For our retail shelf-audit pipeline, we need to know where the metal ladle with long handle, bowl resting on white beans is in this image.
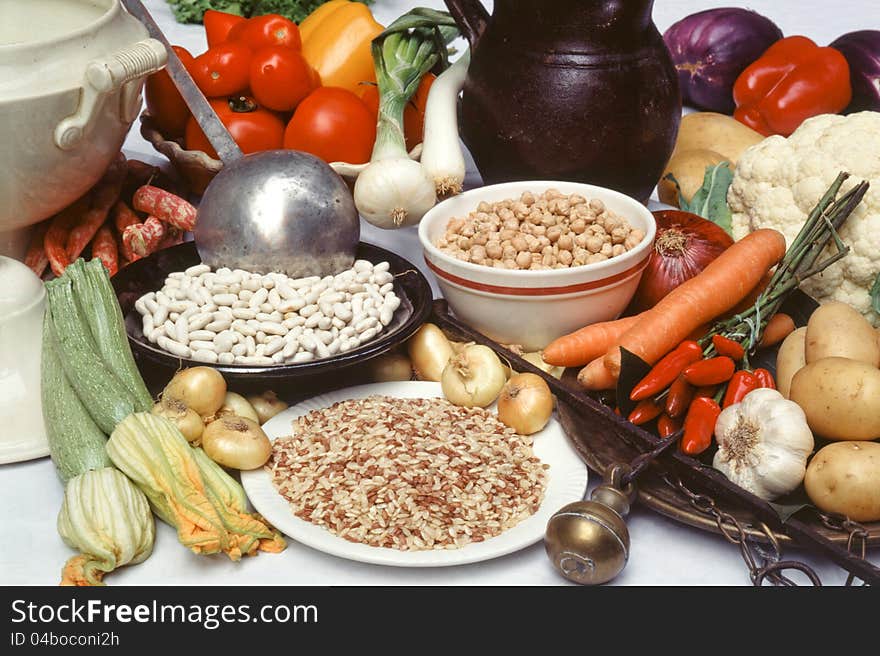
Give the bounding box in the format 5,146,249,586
122,0,360,277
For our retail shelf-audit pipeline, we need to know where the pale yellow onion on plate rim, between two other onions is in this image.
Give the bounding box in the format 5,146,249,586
440,344,507,408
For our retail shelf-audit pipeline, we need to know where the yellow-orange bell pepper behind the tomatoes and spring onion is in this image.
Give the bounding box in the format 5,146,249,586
299,0,385,93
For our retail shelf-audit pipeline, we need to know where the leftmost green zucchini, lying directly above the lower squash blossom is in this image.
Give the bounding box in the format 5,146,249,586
40,314,112,483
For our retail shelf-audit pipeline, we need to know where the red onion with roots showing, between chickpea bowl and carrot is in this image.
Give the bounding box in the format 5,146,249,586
630,210,733,312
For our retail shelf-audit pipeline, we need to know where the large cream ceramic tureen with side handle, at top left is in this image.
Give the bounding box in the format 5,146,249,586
0,0,167,258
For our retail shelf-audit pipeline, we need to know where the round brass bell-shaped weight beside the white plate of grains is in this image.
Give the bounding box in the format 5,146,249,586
544,465,635,585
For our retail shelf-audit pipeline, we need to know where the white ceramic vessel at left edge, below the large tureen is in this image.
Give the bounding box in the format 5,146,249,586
0,255,49,463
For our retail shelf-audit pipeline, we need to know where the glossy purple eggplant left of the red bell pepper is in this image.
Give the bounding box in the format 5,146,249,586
663,7,782,114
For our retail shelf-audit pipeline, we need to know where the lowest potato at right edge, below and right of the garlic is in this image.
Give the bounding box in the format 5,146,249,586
804,442,880,522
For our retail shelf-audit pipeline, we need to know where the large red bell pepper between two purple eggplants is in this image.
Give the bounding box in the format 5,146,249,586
733,36,852,137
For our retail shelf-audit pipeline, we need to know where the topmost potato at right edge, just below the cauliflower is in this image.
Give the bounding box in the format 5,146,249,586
804,301,880,367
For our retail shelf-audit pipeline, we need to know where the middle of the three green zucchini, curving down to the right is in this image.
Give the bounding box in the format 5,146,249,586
46,276,142,435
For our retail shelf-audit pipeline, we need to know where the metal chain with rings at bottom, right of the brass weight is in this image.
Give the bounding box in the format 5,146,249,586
661,472,822,586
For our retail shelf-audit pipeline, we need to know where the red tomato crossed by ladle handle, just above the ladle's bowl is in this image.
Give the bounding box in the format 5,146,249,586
186,96,284,159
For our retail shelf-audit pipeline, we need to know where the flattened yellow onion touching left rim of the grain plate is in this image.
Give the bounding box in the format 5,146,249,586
202,415,272,469
